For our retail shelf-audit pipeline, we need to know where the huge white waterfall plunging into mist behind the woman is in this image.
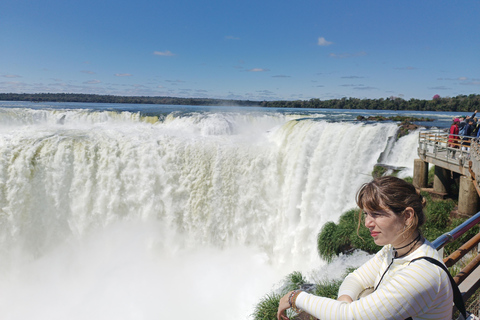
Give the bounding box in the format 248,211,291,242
0,104,416,319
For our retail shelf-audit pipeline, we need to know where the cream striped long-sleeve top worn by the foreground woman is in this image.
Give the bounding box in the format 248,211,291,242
295,240,453,320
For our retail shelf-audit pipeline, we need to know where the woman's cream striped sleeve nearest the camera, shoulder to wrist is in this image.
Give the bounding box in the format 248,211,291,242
295,262,453,320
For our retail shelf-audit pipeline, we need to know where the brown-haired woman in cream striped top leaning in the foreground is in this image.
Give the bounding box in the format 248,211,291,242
277,177,453,320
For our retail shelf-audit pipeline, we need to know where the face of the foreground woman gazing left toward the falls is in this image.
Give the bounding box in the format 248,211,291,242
364,209,405,247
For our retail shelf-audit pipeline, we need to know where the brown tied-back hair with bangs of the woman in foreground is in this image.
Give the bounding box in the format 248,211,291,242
356,176,425,235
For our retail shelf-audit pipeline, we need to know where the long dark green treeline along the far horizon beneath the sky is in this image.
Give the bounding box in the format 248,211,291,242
0,93,480,113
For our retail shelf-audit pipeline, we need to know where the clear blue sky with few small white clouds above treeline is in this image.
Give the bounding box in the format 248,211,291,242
0,0,480,100
